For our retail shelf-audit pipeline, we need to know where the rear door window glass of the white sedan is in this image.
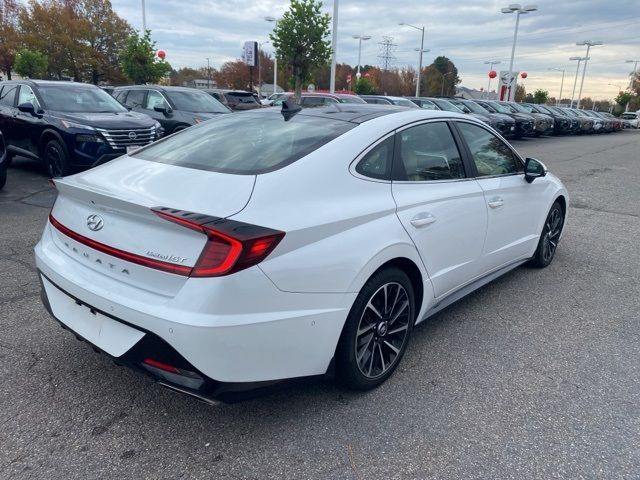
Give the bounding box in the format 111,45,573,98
395,122,465,182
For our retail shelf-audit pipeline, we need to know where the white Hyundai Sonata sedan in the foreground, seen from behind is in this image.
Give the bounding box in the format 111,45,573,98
35,103,569,401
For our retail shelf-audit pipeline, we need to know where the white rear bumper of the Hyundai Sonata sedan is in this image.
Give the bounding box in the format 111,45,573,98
35,224,356,398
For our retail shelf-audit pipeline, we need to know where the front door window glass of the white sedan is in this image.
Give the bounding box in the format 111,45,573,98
457,122,518,177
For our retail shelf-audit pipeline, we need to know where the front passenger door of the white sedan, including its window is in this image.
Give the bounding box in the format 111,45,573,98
455,121,549,273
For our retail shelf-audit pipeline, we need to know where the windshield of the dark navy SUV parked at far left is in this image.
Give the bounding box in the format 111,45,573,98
38,84,127,113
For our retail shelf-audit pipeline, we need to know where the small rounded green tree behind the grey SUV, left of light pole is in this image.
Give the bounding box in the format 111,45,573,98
120,30,171,84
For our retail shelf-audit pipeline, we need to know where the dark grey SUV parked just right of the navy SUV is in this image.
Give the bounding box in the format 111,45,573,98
113,85,231,135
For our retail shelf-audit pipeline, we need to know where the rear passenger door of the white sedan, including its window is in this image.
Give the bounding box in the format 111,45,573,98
392,121,487,298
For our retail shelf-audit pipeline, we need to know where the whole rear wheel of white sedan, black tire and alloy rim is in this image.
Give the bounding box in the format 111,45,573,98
336,267,416,390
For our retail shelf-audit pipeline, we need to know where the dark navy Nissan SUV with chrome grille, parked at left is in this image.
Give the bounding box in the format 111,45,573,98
0,80,162,177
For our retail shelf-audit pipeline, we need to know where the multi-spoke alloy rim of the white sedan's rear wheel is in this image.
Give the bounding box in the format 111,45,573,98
354,282,411,379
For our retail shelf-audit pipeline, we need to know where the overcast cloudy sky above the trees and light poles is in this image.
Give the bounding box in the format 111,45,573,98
112,0,640,98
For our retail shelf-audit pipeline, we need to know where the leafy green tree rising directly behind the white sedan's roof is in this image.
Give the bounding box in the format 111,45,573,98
269,0,331,101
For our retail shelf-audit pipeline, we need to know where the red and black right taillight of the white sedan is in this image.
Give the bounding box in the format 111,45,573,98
152,207,284,277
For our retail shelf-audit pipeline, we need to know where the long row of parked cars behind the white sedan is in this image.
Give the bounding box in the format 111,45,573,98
0,80,637,188
